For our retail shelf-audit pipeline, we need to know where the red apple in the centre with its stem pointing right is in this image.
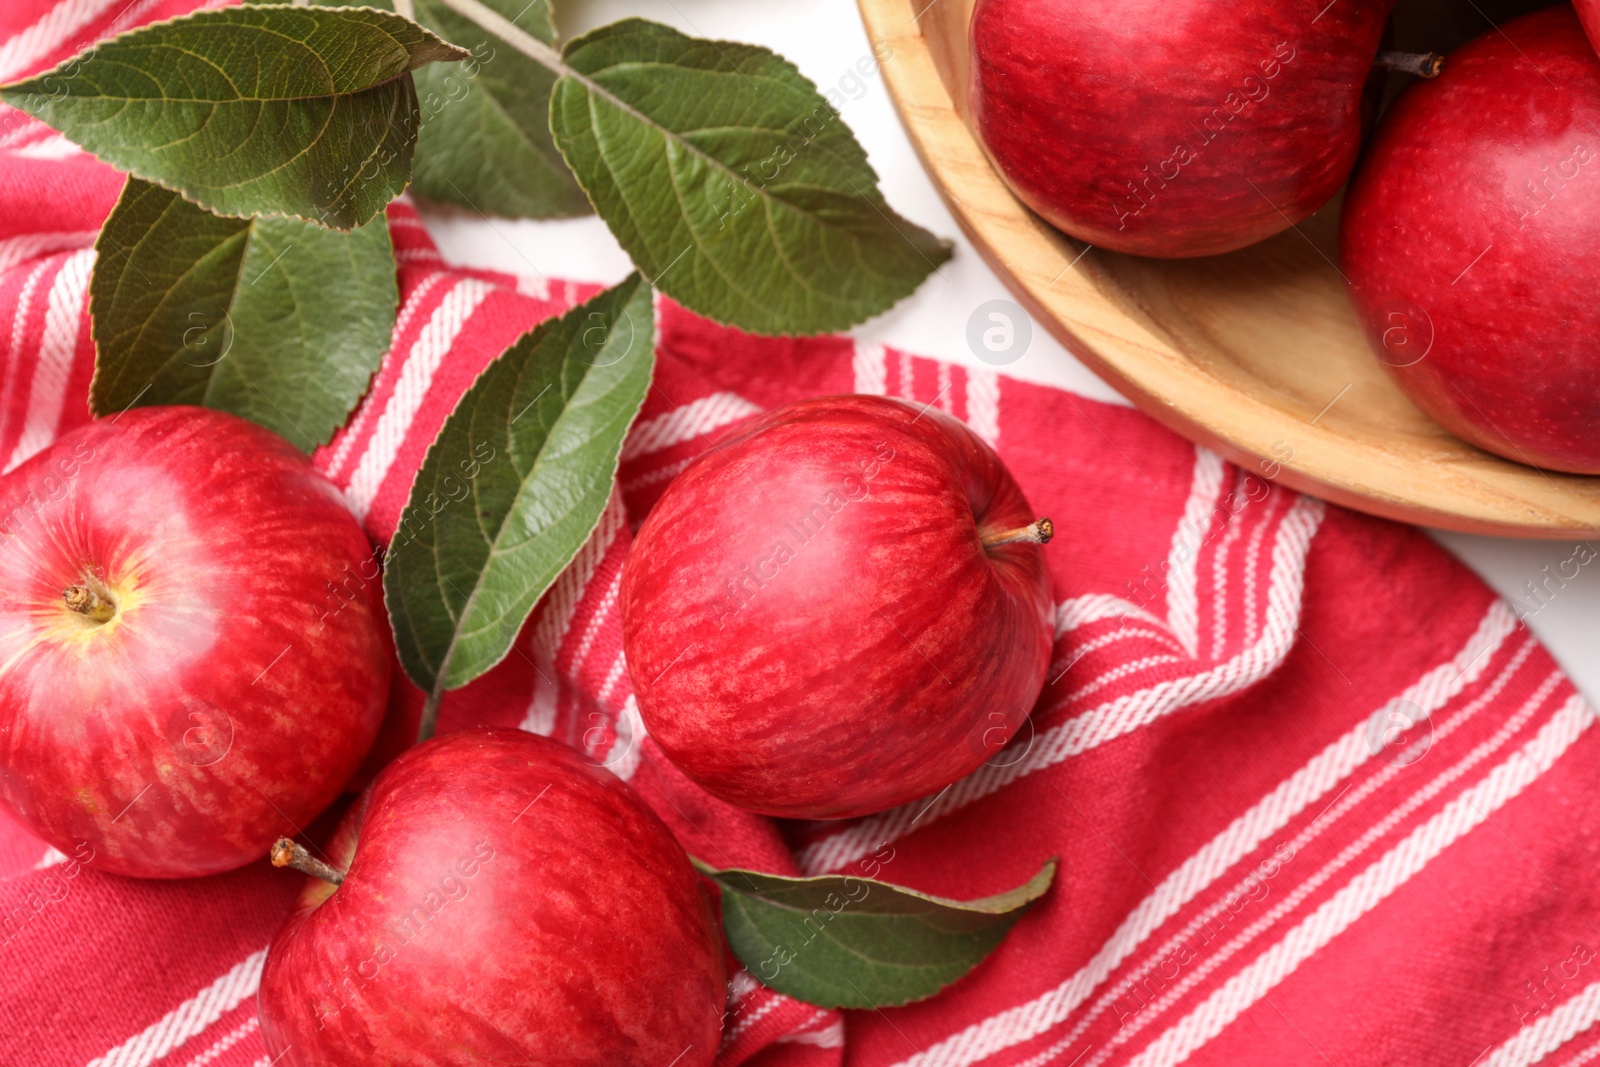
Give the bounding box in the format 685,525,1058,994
621,397,1053,819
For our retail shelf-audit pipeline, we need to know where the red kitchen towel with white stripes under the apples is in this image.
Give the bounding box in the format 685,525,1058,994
0,0,1600,1067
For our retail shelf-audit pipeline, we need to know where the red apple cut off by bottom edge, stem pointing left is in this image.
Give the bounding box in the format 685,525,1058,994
259,729,726,1067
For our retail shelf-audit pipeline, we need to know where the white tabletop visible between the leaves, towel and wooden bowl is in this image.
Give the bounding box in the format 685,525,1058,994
427,0,1600,704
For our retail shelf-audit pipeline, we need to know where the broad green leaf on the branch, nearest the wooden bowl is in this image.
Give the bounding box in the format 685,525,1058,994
550,16,950,334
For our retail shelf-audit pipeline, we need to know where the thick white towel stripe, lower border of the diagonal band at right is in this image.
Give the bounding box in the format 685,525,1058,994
1130,696,1595,1067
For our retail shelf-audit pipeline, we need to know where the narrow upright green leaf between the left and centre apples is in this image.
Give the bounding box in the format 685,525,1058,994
384,274,656,736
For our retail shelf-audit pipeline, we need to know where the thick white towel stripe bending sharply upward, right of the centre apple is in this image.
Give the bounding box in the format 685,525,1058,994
797,496,1326,873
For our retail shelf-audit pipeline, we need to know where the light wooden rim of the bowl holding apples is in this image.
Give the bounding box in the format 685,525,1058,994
858,0,1600,539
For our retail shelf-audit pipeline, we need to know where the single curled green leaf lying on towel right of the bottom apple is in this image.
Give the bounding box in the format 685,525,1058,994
694,861,1056,1008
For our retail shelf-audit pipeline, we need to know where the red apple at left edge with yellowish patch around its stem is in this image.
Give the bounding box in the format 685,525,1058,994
0,408,389,878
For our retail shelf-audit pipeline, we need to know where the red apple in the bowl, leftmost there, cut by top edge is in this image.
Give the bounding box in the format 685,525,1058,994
970,0,1394,256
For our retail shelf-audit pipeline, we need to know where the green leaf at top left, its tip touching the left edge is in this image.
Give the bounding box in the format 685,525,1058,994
0,6,467,230
